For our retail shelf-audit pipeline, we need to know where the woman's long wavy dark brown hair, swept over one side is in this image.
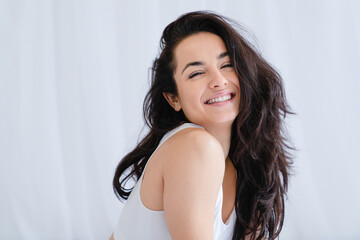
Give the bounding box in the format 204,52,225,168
113,11,292,240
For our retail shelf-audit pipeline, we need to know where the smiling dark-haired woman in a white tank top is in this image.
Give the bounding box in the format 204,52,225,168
113,12,290,239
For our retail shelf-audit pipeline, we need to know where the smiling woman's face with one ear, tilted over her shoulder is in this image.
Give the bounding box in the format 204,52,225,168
164,32,240,128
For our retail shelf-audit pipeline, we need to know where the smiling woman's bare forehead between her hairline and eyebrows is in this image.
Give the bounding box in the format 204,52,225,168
174,32,227,67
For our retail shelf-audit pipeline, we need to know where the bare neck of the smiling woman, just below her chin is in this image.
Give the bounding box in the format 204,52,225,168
203,123,232,159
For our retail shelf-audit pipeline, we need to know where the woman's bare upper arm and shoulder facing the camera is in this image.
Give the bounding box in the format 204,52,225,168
163,129,225,239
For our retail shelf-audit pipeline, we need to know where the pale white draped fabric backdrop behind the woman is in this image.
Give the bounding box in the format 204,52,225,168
0,0,360,240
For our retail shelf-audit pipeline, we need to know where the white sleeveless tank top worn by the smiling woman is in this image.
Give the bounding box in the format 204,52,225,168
114,123,236,240
